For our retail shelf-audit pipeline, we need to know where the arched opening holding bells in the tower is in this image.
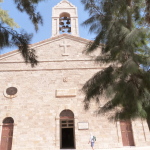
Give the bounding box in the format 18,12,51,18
59,12,71,34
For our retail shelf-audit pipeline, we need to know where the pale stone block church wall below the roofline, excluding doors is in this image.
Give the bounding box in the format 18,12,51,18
0,35,150,150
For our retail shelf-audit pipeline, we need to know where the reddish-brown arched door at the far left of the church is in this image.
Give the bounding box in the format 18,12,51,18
0,117,14,150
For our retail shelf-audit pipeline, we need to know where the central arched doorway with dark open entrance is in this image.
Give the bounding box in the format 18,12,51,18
60,109,75,149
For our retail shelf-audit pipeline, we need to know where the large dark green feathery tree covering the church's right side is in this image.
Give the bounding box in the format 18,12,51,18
82,0,150,120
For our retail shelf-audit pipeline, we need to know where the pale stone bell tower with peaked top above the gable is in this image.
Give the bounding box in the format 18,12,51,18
52,0,79,37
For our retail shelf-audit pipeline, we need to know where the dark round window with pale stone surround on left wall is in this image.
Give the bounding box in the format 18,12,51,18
4,87,18,98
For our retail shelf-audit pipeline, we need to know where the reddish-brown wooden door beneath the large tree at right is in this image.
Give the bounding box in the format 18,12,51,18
120,121,134,146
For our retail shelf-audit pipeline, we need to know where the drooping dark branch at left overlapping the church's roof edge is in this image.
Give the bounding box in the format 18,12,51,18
0,25,38,67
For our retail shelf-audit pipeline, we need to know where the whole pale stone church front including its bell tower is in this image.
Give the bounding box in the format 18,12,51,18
0,0,150,150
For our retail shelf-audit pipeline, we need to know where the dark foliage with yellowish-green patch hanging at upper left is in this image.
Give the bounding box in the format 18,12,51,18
0,0,44,67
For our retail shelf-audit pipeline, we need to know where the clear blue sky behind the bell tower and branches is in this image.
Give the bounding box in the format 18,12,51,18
0,0,95,54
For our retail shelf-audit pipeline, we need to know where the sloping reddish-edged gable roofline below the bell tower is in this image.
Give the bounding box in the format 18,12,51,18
0,34,90,60
